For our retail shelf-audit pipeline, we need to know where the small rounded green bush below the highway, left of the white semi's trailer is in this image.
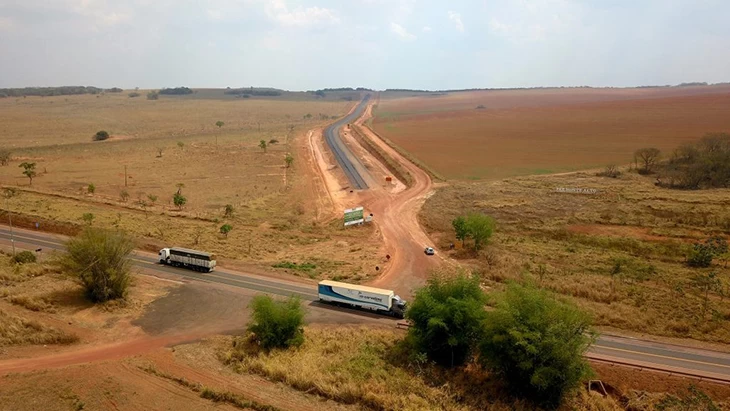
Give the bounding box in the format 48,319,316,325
248,295,304,350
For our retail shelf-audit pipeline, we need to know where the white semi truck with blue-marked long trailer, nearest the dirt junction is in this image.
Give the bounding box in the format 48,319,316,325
318,280,407,318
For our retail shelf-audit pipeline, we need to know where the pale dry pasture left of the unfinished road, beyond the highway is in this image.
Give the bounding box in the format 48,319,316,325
0,90,378,281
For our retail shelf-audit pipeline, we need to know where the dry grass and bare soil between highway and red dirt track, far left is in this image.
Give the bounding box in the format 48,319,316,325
0,254,169,352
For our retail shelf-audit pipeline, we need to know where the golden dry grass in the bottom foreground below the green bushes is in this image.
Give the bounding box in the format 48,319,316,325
221,327,620,410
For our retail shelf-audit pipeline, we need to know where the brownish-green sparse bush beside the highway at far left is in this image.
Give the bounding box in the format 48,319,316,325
60,227,134,302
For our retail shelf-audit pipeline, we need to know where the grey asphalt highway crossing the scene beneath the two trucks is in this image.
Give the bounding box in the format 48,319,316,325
0,226,730,382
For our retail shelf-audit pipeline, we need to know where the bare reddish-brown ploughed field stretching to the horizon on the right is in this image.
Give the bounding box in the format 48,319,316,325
373,86,730,180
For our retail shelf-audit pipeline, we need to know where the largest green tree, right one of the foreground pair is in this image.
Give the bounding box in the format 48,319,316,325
479,284,594,407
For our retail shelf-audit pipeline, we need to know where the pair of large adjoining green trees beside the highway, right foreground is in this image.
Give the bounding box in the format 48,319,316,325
406,274,593,407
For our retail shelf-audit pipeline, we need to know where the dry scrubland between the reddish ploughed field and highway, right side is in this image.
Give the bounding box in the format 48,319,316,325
419,172,730,343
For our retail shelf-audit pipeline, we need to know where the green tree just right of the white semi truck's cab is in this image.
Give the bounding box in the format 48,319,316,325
406,273,486,367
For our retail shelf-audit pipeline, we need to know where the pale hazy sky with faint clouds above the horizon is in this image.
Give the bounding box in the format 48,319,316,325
0,0,730,90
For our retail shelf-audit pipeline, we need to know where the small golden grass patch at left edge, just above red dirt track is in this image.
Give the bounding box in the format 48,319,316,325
0,310,79,347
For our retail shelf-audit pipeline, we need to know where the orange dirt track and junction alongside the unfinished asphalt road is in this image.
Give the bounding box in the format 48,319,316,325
310,98,455,299
